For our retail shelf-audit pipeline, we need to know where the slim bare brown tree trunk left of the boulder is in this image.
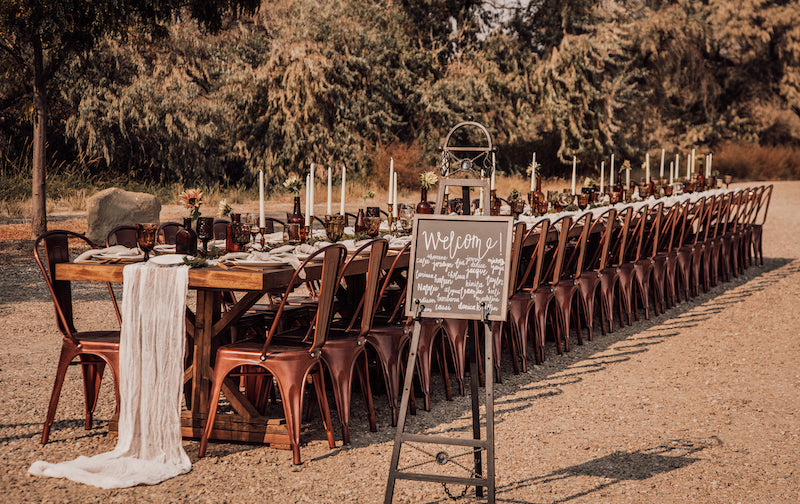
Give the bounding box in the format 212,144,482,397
31,37,47,239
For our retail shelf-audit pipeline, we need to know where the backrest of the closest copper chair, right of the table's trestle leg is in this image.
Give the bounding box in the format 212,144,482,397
261,243,347,354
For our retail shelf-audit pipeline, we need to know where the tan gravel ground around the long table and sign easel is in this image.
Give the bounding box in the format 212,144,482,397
0,182,800,504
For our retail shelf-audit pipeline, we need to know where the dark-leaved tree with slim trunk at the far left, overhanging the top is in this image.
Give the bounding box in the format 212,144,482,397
0,0,259,236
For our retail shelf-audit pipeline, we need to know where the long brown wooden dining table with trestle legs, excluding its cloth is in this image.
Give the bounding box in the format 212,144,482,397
55,253,408,449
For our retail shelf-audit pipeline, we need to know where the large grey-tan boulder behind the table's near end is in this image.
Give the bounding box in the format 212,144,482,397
86,187,161,245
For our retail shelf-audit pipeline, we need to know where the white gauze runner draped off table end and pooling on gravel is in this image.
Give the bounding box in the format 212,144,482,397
28,263,192,488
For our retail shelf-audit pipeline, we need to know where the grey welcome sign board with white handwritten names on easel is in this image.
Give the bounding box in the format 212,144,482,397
406,215,514,321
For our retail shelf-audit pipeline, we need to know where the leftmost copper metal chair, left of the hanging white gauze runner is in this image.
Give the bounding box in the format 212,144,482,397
33,230,119,444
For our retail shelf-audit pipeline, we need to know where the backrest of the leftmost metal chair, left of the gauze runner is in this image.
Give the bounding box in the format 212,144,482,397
33,230,97,345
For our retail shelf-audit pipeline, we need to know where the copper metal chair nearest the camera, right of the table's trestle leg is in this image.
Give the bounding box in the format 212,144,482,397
199,244,347,464
